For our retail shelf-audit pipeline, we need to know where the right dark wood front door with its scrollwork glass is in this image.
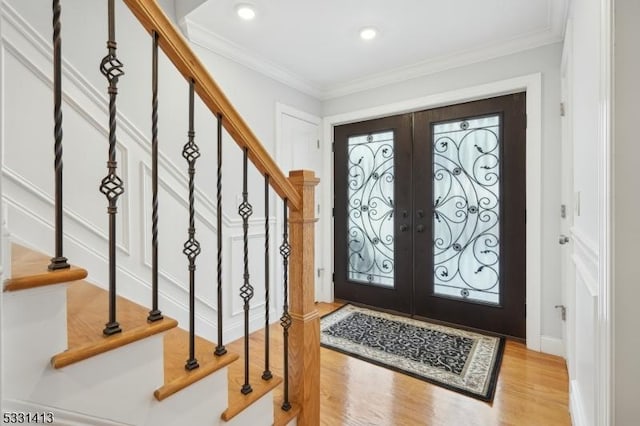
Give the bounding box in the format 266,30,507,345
412,93,526,338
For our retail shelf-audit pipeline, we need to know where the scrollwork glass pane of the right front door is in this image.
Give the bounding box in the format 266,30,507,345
433,115,500,304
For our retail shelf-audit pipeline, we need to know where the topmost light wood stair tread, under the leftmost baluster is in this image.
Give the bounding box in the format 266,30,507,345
4,243,87,291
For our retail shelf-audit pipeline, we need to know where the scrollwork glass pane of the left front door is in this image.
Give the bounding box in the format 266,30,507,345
347,131,394,287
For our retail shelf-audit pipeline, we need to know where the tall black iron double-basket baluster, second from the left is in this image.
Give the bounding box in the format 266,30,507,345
100,0,124,336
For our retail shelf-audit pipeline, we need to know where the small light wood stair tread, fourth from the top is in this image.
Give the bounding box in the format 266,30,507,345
220,360,282,421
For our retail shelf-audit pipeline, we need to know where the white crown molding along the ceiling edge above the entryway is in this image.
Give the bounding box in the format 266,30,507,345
180,0,569,100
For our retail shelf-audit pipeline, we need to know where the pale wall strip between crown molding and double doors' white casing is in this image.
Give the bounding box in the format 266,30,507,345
323,44,562,341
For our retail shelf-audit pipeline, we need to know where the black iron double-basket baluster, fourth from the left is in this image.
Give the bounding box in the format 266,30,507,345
182,80,200,370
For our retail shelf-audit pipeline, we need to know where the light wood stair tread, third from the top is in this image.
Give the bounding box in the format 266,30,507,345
153,327,238,401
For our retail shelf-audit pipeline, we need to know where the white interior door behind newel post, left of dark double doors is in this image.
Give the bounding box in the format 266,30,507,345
277,105,326,300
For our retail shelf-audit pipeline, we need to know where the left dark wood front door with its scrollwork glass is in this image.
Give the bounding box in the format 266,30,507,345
334,114,413,312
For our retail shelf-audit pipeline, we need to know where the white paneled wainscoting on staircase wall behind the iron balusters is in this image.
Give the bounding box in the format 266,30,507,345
0,2,282,341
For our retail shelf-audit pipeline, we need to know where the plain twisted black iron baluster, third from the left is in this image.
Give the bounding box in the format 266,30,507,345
147,31,162,322
